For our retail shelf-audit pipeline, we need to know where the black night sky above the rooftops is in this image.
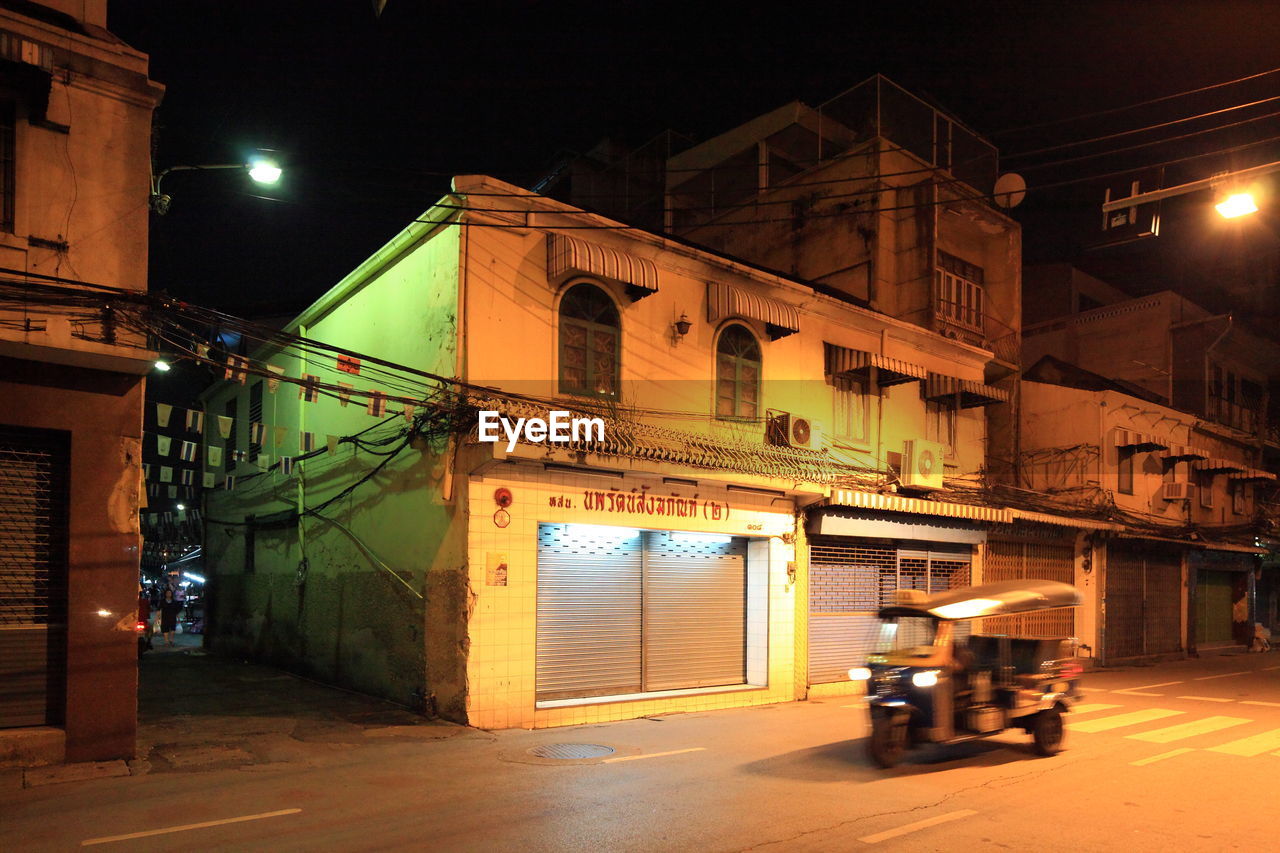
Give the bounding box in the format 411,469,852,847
110,0,1280,322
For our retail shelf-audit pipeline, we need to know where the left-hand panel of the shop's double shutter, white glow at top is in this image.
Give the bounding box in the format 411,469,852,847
536,524,643,699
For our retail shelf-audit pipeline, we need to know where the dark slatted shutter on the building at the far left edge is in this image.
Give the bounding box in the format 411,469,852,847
0,427,70,727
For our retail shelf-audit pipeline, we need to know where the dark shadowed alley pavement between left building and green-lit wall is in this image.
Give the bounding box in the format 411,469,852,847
129,634,468,775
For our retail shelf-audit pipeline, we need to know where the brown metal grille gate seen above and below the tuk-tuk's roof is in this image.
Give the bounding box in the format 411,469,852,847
982,539,1075,638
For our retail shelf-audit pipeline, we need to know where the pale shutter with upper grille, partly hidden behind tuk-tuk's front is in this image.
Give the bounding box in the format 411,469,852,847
809,537,972,684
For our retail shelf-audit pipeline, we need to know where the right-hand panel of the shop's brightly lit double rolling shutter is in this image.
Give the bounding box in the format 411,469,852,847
644,532,746,690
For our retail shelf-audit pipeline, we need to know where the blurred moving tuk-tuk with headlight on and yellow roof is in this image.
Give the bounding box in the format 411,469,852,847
849,580,1082,767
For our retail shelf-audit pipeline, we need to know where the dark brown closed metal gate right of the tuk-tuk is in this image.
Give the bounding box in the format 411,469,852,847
1103,540,1183,661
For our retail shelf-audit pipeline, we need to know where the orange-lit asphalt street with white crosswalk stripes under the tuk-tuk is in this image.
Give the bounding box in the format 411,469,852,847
0,653,1280,852
